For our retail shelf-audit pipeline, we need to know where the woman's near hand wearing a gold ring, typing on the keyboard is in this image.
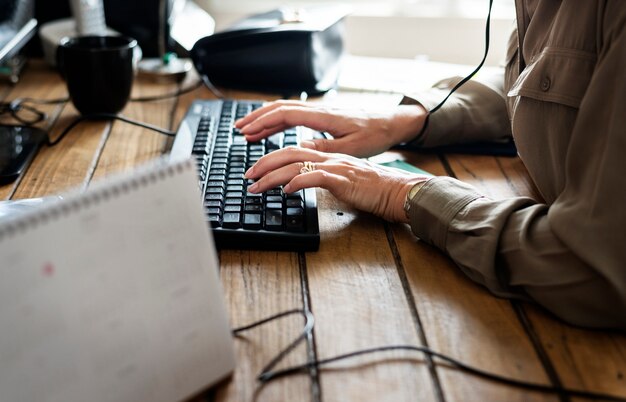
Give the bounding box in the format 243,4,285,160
246,147,430,222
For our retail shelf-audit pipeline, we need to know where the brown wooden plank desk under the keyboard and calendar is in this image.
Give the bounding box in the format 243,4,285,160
0,62,626,402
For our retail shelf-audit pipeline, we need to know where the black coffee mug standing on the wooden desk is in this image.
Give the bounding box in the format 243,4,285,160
57,36,137,115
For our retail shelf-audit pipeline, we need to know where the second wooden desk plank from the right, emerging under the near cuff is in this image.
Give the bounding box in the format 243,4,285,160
393,153,555,401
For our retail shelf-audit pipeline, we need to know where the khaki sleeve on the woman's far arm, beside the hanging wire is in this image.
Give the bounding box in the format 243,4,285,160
401,71,511,148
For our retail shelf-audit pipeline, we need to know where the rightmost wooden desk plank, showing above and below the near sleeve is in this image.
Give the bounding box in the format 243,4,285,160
450,157,626,397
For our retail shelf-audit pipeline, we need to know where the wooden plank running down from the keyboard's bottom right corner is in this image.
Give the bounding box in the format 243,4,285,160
307,190,435,401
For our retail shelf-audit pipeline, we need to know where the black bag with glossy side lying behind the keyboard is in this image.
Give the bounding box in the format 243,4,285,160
190,7,346,96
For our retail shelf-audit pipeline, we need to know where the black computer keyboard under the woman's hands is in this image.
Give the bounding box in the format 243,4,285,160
171,100,320,251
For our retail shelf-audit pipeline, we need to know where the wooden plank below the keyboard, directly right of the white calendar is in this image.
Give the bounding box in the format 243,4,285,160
215,250,311,402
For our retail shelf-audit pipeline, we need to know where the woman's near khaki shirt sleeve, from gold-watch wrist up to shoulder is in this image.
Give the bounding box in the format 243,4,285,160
410,7,626,330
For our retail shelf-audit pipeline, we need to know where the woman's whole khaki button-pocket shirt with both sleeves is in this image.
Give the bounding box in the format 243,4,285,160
404,0,626,329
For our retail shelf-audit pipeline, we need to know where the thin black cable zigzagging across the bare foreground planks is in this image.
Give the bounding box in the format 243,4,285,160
233,310,626,402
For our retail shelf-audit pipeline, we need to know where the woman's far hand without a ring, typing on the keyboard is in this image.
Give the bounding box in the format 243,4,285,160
235,101,427,157
